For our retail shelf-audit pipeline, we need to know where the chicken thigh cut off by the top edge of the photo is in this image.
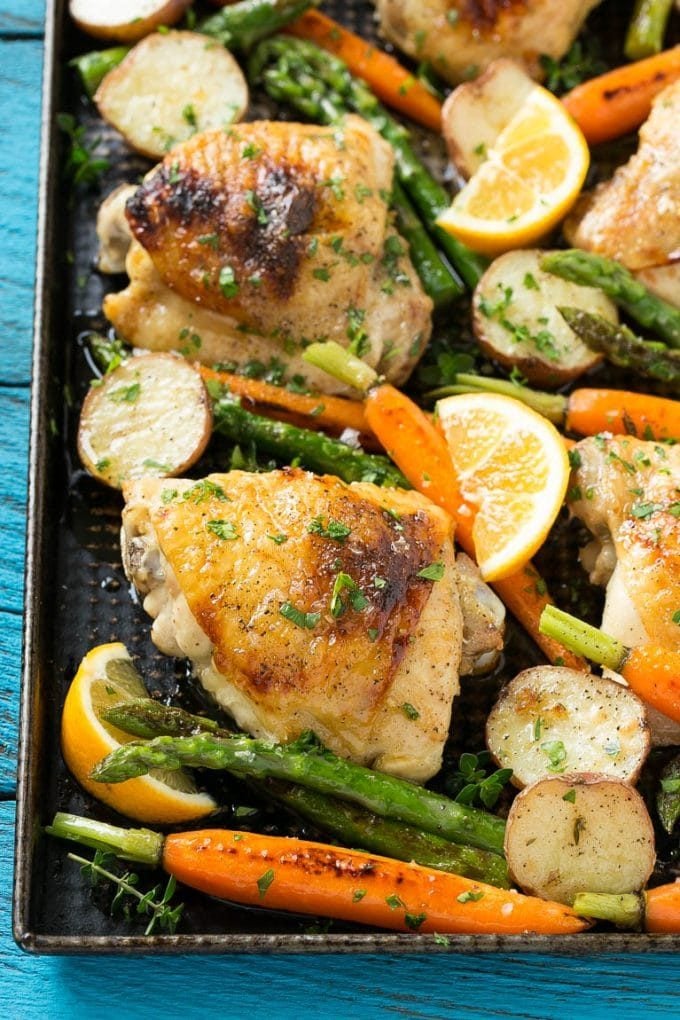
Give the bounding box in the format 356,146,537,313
376,0,599,85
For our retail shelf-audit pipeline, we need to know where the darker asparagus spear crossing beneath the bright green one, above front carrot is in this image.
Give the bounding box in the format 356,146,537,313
103,698,509,888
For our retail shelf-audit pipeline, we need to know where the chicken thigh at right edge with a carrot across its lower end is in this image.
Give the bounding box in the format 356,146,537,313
570,437,680,744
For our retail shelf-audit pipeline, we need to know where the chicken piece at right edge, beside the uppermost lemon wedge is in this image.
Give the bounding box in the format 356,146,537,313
565,82,680,287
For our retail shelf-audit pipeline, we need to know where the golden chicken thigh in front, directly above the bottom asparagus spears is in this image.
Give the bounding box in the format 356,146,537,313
122,468,462,781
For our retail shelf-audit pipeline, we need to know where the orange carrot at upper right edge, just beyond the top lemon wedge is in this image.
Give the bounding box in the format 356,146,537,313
562,46,680,144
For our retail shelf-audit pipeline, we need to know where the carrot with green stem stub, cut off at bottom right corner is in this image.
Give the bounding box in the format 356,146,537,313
574,879,680,935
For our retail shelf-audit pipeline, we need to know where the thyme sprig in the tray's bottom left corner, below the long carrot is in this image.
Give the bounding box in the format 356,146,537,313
67,850,185,935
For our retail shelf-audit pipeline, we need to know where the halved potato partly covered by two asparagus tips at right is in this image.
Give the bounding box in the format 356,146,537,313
472,249,619,387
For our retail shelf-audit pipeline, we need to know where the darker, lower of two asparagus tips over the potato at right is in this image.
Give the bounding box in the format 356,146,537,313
559,308,680,393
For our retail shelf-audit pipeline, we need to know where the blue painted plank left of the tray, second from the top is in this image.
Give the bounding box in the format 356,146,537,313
0,37,42,385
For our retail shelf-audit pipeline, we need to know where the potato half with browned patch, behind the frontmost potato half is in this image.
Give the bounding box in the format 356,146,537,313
486,666,649,786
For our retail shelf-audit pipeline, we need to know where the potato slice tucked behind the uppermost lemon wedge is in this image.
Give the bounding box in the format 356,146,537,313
441,57,534,177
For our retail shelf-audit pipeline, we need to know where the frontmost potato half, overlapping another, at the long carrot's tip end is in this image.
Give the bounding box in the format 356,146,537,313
505,774,656,905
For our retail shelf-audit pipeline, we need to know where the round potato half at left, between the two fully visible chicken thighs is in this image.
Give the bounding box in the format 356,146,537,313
77,354,212,489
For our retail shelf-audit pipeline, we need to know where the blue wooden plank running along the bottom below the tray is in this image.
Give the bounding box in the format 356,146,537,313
0,802,678,1020
